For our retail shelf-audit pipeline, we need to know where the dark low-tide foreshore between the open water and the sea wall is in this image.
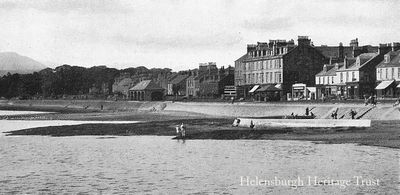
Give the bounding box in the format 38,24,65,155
0,101,400,149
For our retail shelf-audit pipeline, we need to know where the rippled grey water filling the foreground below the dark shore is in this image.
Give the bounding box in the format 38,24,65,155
0,111,400,194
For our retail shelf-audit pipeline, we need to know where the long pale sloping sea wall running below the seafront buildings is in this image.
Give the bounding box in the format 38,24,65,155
0,100,400,120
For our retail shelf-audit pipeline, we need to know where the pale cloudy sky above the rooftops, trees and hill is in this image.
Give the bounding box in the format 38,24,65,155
0,0,400,71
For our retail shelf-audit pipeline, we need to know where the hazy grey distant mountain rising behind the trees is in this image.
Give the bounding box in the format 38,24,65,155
0,52,47,76
